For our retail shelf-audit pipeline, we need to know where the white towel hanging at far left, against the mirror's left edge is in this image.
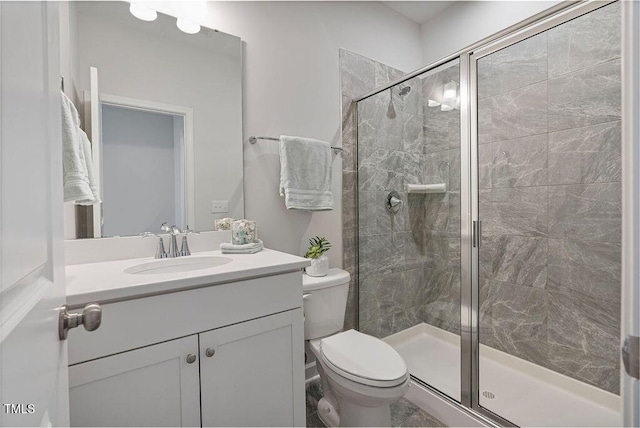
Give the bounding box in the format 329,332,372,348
61,92,100,205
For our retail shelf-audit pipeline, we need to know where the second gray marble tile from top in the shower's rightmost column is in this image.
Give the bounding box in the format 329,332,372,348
549,60,621,131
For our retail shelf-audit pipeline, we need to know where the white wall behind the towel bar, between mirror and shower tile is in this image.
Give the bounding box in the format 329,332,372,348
148,1,421,266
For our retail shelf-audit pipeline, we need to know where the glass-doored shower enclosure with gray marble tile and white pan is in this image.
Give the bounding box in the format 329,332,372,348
356,2,622,426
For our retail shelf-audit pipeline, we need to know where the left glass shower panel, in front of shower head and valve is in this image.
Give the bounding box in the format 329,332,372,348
357,60,461,401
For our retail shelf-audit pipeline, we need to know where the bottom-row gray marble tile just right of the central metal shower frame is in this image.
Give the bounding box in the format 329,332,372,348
480,281,548,365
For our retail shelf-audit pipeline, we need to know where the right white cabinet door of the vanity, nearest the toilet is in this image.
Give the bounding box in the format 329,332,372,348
200,309,305,426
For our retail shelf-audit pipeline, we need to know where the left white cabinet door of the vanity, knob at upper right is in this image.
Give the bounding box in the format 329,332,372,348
69,335,200,426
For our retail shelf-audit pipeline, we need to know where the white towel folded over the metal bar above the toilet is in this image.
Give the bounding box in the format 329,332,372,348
280,135,333,211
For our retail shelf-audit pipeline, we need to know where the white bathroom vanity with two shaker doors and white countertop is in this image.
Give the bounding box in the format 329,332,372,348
67,250,309,426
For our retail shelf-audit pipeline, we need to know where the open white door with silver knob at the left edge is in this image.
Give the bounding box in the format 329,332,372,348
0,2,69,426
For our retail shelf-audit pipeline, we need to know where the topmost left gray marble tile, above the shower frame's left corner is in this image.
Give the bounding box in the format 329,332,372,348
339,49,375,98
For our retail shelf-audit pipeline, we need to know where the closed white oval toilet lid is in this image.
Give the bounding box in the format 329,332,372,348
320,330,407,386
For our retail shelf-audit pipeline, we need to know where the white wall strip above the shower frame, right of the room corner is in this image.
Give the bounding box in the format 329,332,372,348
421,1,561,65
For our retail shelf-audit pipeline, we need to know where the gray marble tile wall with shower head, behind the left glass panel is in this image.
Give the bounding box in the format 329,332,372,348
342,47,460,337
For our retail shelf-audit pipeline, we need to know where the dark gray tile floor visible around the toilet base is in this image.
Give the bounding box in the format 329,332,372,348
307,380,446,428
